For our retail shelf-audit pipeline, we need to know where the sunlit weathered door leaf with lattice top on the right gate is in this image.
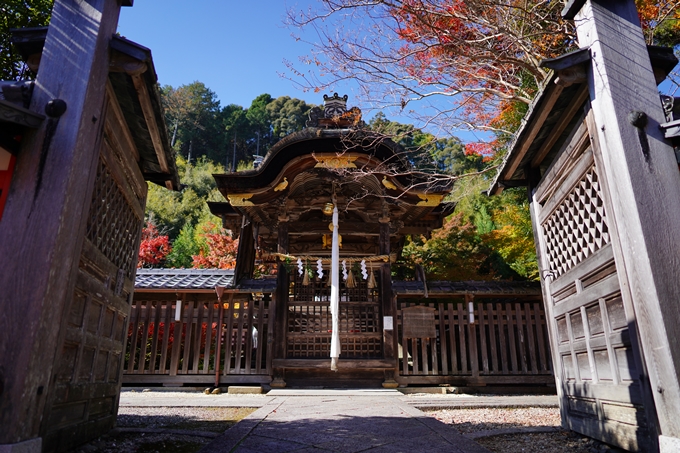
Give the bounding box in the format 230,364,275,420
532,120,656,451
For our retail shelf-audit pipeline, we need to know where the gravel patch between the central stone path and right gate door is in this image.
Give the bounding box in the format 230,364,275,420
425,407,623,453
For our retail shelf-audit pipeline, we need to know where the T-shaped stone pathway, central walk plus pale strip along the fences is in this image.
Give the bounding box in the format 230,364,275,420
121,389,557,453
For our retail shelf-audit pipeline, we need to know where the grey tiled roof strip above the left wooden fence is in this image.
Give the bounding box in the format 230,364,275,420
135,269,234,290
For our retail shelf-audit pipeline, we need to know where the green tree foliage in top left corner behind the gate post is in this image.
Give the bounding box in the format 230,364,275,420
0,0,54,80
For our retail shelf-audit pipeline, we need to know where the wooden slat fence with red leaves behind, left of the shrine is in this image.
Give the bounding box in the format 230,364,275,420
124,297,273,382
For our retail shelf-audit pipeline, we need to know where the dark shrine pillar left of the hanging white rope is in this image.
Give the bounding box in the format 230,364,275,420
271,217,290,388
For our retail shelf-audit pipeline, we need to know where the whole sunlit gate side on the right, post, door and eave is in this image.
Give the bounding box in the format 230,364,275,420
490,0,680,452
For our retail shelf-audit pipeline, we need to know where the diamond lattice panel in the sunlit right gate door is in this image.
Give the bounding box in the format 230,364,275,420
542,167,610,278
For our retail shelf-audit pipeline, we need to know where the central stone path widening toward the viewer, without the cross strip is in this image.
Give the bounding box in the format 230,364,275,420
201,395,489,453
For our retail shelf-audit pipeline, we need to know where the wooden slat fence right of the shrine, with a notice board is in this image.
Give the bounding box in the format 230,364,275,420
397,301,552,383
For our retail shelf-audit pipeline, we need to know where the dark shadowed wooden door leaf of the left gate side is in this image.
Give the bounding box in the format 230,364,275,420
42,93,147,452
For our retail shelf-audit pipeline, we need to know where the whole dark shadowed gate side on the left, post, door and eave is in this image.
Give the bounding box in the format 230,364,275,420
0,0,179,453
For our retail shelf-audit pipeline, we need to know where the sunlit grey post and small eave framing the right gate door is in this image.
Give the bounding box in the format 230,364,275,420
490,0,680,452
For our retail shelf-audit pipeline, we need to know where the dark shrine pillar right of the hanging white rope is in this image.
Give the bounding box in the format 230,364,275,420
379,217,399,388
